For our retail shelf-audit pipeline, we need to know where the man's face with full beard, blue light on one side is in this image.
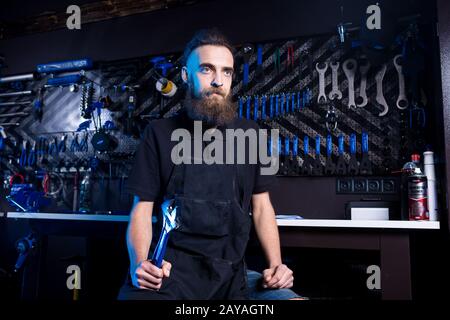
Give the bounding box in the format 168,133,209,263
181,45,235,125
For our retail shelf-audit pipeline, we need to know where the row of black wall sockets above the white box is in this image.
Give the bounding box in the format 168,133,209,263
336,177,397,194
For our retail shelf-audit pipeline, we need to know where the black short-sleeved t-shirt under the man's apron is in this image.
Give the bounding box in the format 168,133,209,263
126,111,274,214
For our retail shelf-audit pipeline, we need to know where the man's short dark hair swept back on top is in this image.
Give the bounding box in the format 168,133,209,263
183,28,234,65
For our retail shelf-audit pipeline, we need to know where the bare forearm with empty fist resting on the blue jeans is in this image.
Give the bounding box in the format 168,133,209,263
252,192,294,288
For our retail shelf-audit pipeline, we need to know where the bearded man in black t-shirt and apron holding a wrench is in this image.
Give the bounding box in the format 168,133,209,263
119,29,295,300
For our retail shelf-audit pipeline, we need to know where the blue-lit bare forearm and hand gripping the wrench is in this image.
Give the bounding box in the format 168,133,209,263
127,197,172,290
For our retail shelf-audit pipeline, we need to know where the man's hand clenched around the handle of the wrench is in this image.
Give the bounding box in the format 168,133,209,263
131,260,172,290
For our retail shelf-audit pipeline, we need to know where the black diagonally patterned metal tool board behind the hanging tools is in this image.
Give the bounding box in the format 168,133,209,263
1,28,438,216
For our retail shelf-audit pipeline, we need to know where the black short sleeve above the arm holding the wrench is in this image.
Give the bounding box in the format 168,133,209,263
126,125,161,201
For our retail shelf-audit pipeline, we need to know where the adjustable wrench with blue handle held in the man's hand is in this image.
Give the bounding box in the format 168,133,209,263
151,199,178,268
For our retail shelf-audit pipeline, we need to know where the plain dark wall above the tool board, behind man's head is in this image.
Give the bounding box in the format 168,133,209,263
0,0,432,74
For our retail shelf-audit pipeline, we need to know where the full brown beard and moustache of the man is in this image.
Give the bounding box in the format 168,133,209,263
184,86,236,126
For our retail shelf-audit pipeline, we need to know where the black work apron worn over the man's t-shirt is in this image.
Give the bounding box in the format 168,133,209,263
121,133,251,300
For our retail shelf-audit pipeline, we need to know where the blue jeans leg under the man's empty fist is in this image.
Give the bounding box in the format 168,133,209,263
247,270,303,300
